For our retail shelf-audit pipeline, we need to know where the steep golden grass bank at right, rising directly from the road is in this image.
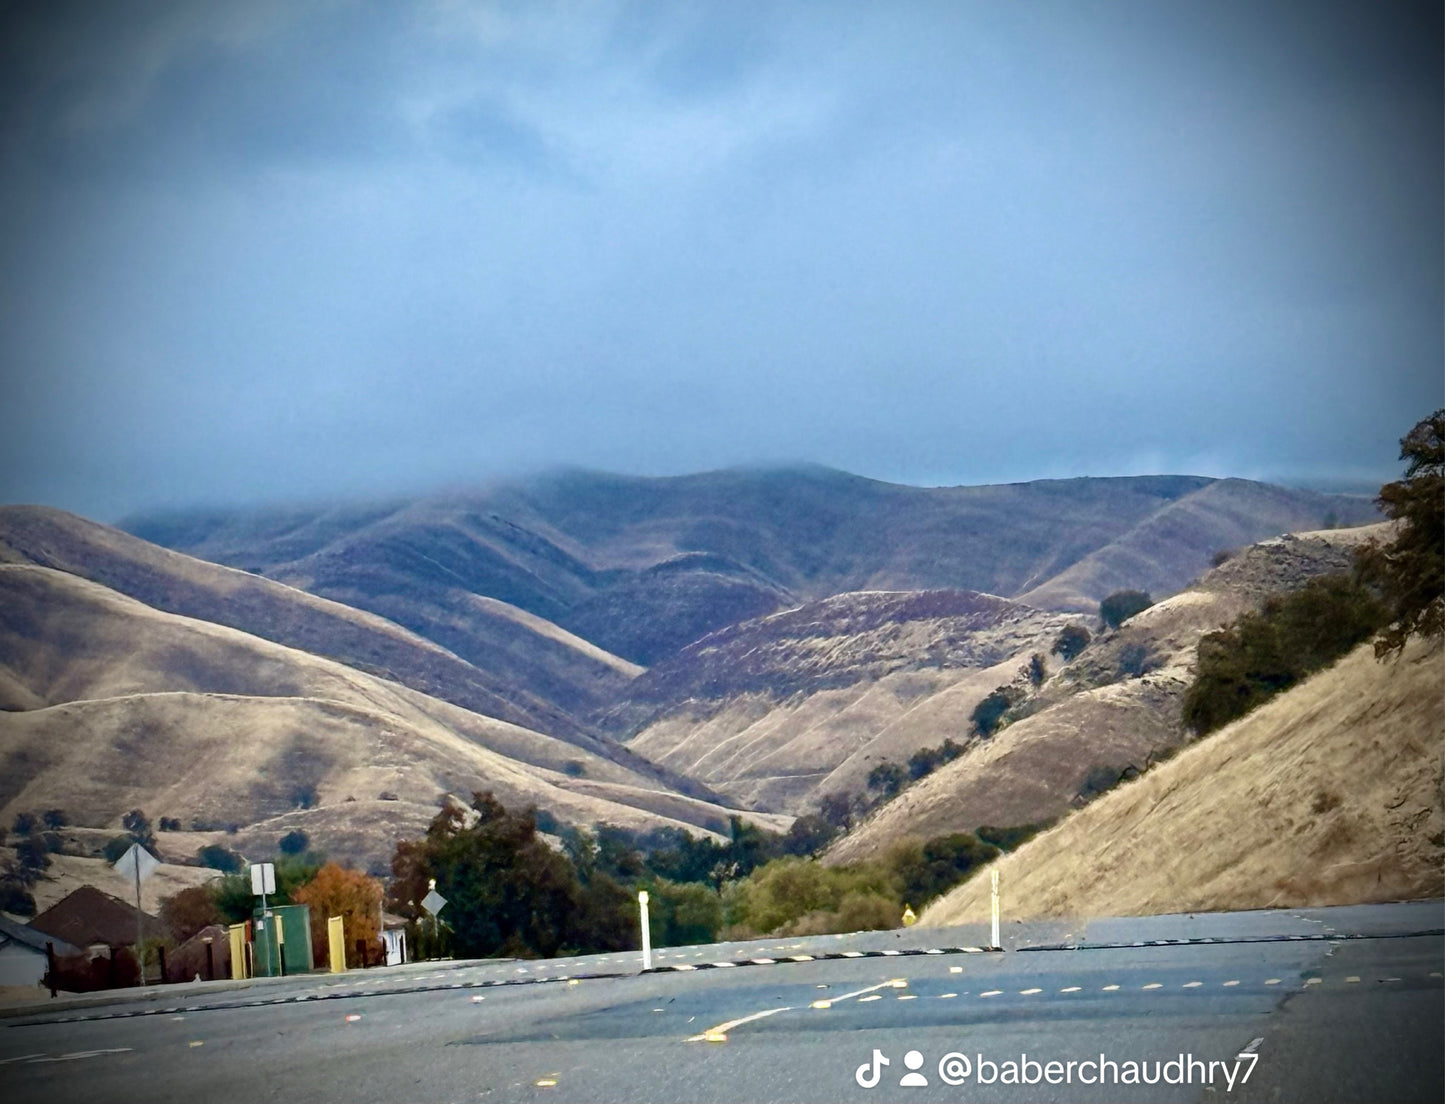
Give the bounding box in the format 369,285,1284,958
920,630,1445,925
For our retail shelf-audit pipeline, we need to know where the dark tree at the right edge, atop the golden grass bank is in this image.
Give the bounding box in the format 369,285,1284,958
1355,409,1445,659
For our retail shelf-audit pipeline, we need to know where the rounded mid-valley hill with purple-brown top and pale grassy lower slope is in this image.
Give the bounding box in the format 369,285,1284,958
627,591,1064,814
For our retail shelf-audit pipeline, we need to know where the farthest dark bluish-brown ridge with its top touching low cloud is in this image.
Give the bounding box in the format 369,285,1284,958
123,467,1374,668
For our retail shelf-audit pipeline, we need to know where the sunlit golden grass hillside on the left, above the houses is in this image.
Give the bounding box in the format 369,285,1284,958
0,565,786,861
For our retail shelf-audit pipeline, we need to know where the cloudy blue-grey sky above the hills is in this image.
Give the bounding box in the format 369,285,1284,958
0,0,1445,520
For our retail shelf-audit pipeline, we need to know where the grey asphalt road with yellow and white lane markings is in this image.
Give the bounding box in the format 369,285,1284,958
0,902,1445,1104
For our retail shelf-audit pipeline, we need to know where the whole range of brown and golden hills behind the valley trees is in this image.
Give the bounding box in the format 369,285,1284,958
0,467,1376,867
